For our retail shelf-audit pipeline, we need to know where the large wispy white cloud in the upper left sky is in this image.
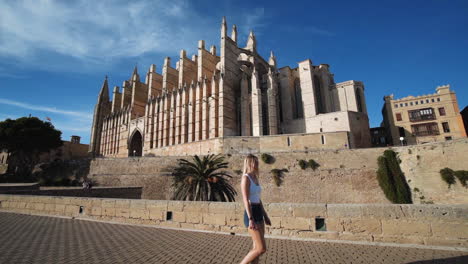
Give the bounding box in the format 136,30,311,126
0,0,214,63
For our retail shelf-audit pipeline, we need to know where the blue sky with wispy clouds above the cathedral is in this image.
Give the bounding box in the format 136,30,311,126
0,0,468,143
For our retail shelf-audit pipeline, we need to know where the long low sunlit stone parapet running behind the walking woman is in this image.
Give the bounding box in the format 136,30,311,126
0,195,468,248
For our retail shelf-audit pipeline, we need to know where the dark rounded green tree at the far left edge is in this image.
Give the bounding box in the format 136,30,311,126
0,117,63,182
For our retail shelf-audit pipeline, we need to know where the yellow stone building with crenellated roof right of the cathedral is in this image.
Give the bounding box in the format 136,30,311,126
382,85,466,145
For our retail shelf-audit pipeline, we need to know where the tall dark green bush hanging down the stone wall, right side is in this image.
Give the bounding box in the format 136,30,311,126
377,150,412,204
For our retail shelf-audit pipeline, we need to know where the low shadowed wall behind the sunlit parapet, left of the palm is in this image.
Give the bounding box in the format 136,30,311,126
0,185,142,199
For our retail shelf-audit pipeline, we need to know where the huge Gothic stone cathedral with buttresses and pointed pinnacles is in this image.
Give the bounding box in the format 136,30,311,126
90,18,370,157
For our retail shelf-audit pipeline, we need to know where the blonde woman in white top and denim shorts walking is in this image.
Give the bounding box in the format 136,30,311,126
241,154,271,264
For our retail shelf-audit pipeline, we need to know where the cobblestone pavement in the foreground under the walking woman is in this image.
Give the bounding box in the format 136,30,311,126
0,212,468,264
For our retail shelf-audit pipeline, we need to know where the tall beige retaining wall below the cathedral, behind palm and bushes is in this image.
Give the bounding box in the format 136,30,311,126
89,137,468,204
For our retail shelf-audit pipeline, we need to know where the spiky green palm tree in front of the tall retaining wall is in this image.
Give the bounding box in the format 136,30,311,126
172,154,237,202
